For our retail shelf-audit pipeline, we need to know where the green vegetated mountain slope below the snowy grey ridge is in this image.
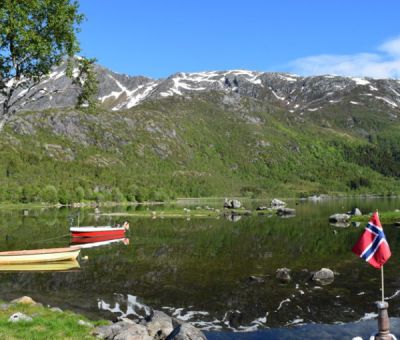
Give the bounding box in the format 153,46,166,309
0,91,400,203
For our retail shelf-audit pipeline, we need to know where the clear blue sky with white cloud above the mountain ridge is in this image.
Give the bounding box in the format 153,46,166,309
79,0,400,78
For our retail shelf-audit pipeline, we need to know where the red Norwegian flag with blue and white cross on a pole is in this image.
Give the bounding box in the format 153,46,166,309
352,212,392,269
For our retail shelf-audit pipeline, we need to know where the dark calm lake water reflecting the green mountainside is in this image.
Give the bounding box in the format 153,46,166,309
0,199,400,338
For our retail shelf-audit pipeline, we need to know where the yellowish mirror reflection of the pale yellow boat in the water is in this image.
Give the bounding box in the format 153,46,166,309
0,260,80,272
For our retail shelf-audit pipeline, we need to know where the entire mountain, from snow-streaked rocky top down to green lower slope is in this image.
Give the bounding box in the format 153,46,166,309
0,66,400,201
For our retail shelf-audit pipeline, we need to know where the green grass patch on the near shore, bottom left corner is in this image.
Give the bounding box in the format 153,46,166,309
0,302,106,340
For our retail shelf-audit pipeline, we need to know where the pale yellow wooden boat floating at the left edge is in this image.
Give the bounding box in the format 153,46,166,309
0,247,81,264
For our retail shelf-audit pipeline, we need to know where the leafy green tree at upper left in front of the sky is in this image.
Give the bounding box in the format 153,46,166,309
0,0,97,131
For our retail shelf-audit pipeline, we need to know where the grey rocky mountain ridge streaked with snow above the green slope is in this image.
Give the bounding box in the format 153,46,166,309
0,65,400,117
